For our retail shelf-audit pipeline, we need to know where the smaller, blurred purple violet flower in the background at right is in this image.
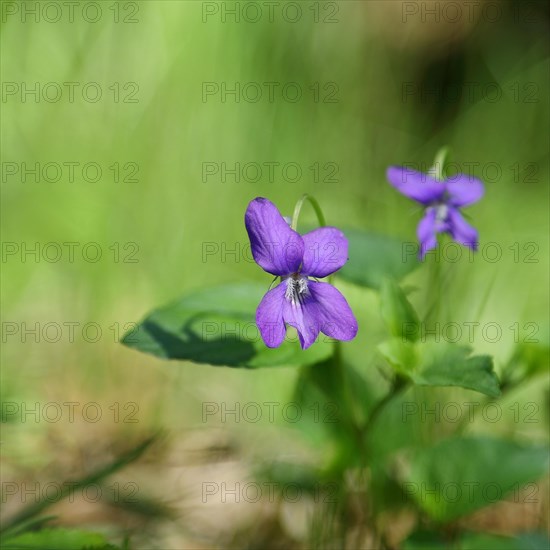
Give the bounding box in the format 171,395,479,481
387,166,484,259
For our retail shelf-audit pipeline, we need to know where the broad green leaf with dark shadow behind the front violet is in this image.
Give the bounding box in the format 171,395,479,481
122,283,333,368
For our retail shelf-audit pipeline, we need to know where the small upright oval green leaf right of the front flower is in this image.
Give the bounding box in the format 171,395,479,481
380,279,420,342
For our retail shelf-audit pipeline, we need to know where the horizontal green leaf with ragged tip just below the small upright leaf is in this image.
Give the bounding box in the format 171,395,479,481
378,338,501,397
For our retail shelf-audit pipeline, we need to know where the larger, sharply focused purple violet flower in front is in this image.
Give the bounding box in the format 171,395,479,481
245,197,357,349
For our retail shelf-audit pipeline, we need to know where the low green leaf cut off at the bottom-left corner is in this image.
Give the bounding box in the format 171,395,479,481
2,528,117,550
